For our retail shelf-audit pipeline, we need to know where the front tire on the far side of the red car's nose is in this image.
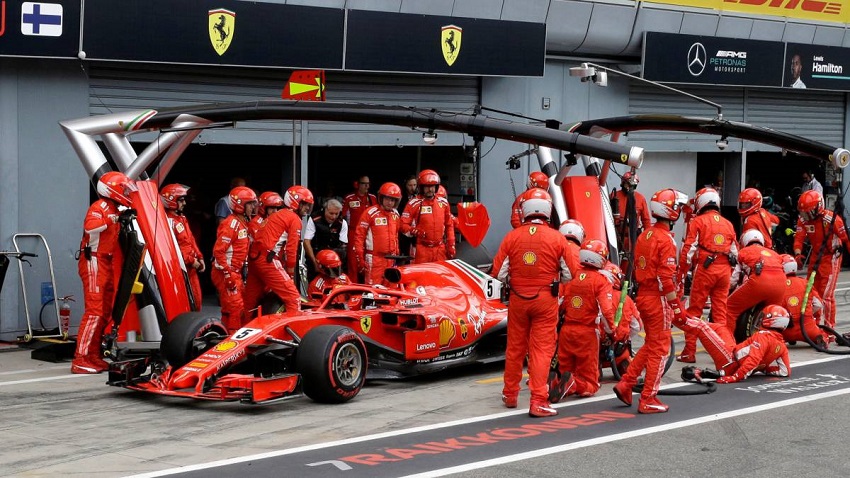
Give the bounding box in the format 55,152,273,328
159,312,228,368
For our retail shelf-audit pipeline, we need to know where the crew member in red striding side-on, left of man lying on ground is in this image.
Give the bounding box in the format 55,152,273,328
614,189,688,413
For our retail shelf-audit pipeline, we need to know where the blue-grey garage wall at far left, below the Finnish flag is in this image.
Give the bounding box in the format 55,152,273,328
0,58,89,340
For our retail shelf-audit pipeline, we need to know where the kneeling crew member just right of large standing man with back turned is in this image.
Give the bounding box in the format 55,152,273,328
549,239,616,403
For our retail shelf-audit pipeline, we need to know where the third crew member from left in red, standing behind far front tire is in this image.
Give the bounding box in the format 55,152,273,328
210,186,257,332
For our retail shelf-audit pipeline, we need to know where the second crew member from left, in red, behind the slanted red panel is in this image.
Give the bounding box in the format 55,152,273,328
159,184,206,311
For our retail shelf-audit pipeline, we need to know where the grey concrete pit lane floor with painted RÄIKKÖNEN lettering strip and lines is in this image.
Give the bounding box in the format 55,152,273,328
0,272,850,478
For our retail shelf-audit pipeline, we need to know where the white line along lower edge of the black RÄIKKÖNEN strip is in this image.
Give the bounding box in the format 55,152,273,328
402,388,850,478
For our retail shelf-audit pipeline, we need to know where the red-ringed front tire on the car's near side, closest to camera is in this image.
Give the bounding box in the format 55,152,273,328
295,325,368,403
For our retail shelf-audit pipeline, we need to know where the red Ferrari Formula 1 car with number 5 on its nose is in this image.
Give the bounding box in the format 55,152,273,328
108,260,507,403
